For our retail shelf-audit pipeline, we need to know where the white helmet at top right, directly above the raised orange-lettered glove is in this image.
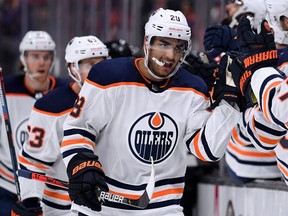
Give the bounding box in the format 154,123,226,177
229,0,267,29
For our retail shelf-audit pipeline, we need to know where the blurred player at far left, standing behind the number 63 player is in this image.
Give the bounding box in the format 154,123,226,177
0,31,66,216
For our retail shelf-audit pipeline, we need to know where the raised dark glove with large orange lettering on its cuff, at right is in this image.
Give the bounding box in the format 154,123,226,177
232,17,278,92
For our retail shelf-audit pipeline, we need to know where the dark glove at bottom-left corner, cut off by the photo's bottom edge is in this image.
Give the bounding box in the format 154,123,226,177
11,197,43,216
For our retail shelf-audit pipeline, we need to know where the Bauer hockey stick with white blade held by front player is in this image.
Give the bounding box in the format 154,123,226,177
18,157,155,209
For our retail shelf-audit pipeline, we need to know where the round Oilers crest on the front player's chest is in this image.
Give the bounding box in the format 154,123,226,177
128,112,178,164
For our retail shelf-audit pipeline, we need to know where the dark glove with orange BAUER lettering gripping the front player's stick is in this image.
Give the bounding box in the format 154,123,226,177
67,153,109,211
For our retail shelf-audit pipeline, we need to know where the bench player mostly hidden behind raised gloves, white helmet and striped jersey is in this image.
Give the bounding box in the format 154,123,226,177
225,0,281,183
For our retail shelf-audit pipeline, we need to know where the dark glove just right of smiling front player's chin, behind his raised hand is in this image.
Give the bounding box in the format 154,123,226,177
182,53,217,91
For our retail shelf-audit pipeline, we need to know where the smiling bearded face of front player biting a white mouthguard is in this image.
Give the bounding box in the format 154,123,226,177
148,37,185,77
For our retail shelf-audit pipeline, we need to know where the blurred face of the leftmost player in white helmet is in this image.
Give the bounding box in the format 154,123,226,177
25,51,53,82
